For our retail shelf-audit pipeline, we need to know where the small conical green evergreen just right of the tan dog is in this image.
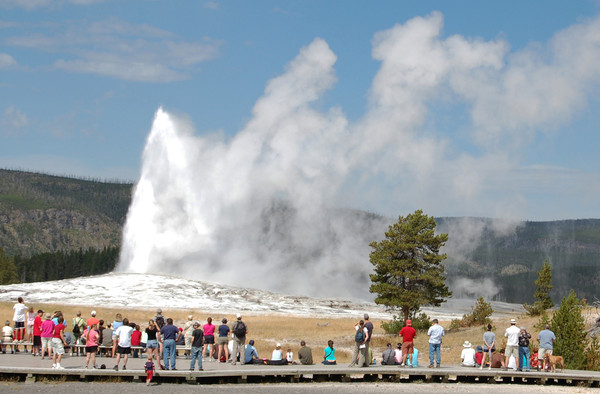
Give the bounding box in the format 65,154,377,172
550,290,586,369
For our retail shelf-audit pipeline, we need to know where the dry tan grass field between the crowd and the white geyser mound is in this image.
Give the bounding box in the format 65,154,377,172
0,302,596,365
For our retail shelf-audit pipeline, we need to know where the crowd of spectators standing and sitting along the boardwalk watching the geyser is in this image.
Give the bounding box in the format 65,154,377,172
0,297,556,379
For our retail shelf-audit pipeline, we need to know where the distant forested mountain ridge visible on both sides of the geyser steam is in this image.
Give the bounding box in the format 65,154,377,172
0,170,600,303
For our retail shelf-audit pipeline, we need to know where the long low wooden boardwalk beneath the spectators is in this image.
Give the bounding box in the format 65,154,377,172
0,353,600,387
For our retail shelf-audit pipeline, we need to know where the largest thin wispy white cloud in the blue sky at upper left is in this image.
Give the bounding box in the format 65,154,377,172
5,19,221,82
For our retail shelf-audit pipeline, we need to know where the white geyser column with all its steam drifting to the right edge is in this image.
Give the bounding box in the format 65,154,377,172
119,13,600,298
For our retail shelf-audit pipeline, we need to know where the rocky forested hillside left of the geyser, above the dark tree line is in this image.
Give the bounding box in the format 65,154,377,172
0,170,132,257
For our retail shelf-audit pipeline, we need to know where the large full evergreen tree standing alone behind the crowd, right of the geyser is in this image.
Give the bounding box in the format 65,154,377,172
369,210,452,320
